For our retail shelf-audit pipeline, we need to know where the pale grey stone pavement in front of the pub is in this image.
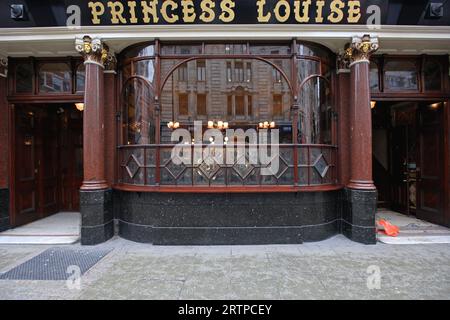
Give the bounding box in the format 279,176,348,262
0,236,450,300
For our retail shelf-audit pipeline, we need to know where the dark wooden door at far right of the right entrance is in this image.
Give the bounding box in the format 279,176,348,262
417,104,445,224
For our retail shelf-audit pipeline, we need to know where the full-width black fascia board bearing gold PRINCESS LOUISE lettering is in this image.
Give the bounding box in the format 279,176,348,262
0,0,450,28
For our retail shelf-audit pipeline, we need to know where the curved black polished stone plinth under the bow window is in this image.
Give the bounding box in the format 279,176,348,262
114,191,341,245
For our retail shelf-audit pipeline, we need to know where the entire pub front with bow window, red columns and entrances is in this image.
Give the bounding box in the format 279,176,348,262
0,0,450,245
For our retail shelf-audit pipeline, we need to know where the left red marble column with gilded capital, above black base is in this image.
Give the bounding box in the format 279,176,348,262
76,36,109,191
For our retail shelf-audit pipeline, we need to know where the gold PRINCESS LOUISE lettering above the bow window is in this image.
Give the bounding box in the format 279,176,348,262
81,0,382,25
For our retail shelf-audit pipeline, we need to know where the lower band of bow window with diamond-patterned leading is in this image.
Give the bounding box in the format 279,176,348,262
118,144,337,188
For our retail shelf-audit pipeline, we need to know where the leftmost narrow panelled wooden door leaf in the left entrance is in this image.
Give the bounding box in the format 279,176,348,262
13,106,39,226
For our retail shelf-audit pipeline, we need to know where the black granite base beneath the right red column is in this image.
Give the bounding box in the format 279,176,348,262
342,188,378,244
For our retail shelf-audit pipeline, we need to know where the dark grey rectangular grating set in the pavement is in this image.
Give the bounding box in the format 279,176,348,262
0,248,112,280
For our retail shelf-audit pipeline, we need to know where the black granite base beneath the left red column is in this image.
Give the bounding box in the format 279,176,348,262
80,189,114,246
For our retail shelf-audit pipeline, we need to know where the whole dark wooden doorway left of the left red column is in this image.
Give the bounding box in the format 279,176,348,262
11,104,83,227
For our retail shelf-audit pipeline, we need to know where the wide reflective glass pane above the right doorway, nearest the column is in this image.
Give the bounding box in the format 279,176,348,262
384,60,419,91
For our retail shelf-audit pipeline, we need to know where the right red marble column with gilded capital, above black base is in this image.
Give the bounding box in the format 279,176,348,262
347,35,378,190
